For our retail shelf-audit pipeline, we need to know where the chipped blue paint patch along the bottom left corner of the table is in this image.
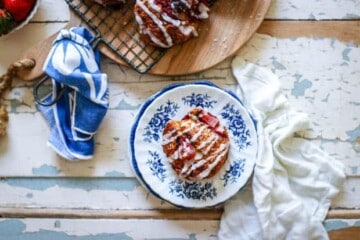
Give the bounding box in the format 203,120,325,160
0,220,133,240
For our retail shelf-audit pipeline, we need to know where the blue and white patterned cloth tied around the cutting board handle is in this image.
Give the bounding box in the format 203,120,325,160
38,27,109,160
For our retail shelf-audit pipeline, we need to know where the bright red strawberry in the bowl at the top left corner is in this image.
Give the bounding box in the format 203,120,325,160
3,0,36,22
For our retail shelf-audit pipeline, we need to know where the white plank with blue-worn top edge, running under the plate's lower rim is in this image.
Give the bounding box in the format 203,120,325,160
0,177,360,209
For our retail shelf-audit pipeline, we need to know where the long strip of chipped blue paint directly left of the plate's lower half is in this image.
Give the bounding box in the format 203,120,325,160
4,177,140,191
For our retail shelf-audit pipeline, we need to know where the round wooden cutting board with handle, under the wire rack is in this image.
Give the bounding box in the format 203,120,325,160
18,0,271,81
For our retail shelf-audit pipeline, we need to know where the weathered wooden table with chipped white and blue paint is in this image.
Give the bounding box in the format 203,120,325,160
0,0,360,240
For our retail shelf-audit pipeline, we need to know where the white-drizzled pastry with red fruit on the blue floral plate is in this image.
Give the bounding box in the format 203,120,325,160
162,108,230,181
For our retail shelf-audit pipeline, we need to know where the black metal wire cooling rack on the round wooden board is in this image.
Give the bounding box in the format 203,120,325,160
65,0,166,73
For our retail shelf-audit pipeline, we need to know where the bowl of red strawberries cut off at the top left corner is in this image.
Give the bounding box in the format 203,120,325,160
0,0,40,37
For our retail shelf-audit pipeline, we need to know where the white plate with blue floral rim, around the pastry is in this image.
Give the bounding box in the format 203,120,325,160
129,82,257,208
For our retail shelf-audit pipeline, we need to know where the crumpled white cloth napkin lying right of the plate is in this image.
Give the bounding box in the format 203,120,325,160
218,56,345,240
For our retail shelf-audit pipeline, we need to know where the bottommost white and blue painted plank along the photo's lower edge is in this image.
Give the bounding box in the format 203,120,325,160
0,218,360,240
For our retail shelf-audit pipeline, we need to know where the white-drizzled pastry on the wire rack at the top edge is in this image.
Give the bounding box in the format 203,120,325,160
134,0,209,48
